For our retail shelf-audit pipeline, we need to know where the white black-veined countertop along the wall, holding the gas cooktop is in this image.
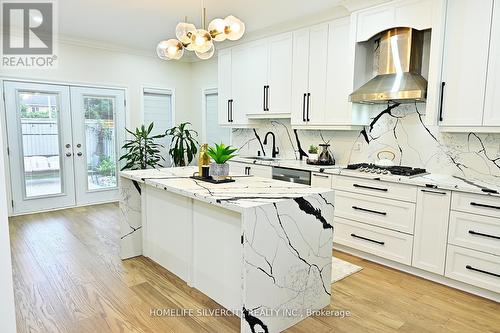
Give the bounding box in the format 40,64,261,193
234,157,500,196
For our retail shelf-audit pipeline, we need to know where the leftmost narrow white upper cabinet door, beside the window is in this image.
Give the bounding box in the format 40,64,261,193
218,49,232,126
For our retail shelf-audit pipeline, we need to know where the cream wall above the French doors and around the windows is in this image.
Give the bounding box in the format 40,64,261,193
0,43,193,127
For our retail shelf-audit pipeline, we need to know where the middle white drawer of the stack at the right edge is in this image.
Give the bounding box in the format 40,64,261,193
448,211,500,255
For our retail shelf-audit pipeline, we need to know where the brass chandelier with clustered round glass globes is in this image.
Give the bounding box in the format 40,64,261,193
156,0,245,60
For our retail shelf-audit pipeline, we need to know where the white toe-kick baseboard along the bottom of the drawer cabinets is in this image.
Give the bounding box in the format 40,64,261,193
333,244,500,303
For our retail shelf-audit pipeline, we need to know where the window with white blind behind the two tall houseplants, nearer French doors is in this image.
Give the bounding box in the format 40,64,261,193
143,88,173,166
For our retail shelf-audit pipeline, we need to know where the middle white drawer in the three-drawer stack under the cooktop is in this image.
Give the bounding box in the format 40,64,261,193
335,191,415,234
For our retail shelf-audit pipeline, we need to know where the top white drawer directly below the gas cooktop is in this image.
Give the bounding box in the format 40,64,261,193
333,176,417,202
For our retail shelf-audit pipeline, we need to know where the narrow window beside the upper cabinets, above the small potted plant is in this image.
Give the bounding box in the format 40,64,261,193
203,89,231,145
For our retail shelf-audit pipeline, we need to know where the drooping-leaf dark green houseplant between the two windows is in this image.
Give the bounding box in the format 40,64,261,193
165,122,198,166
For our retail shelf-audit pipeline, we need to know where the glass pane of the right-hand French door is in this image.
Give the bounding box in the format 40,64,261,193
83,96,117,191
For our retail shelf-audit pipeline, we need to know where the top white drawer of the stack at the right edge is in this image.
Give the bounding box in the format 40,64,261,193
451,192,500,218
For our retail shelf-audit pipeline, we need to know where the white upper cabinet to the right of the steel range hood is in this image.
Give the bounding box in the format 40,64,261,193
439,0,500,132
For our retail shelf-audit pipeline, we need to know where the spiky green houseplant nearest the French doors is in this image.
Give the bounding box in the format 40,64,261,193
120,123,165,170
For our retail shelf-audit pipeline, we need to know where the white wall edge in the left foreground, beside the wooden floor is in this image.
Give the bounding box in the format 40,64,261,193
0,104,16,333
